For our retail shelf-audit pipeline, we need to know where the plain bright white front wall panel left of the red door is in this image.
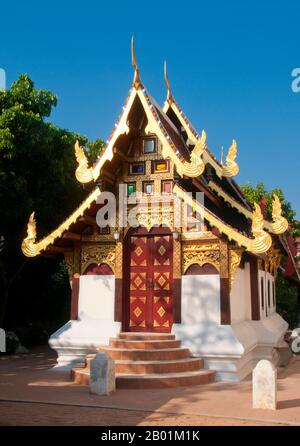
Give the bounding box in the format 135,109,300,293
78,275,115,321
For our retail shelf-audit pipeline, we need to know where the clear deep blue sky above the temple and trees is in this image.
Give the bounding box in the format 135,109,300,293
0,0,300,218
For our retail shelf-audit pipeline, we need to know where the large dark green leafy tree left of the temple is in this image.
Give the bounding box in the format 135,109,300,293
0,74,100,326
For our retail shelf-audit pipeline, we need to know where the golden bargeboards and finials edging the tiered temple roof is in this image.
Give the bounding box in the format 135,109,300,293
22,41,288,257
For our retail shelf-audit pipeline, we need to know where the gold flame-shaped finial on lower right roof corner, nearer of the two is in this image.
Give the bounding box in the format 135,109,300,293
251,203,272,254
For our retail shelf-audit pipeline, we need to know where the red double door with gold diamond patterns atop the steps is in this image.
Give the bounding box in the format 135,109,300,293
127,235,173,332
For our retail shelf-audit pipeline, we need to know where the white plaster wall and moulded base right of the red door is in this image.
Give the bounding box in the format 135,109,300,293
172,263,288,381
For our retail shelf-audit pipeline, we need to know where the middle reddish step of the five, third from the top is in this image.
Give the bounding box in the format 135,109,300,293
99,347,190,361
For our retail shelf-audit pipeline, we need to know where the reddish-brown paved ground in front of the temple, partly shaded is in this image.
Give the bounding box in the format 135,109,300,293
0,349,300,426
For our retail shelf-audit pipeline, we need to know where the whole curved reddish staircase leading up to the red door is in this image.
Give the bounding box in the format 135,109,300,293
72,332,215,389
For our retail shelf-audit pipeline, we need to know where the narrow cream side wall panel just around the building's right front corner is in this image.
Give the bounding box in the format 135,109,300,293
230,262,251,324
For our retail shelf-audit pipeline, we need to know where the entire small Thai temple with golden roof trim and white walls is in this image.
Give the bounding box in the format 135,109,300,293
22,42,288,387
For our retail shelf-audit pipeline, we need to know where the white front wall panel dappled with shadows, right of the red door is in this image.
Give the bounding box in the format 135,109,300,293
181,274,220,324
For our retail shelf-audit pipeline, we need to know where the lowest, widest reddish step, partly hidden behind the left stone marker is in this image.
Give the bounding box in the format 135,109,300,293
72,368,215,389
